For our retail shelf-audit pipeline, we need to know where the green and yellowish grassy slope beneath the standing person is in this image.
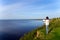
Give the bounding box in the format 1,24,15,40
20,18,60,40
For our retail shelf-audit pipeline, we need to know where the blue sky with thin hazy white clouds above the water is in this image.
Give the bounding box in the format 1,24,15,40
0,0,60,19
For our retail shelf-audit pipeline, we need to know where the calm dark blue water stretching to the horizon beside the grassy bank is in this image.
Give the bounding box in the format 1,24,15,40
0,20,43,40
